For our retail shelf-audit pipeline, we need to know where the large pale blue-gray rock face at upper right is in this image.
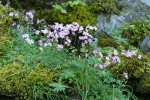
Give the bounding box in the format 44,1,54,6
97,0,150,34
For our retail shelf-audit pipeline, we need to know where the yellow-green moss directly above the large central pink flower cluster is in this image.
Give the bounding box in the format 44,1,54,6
37,4,97,26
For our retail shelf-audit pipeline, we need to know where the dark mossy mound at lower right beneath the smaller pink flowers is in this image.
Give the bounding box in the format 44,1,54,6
108,55,150,94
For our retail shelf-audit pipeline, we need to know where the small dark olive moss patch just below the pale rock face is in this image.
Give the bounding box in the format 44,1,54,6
98,34,117,48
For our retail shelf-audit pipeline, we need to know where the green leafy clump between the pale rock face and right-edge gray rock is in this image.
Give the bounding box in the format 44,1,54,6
122,20,150,47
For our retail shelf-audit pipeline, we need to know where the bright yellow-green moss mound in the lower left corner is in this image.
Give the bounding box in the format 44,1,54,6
0,63,54,100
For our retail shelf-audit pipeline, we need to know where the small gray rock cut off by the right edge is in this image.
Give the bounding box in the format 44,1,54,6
140,35,150,53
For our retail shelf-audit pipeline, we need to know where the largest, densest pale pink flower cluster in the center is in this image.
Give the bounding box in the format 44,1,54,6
35,20,97,50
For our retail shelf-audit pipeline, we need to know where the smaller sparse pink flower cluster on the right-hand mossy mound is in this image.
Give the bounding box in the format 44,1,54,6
93,49,142,79
